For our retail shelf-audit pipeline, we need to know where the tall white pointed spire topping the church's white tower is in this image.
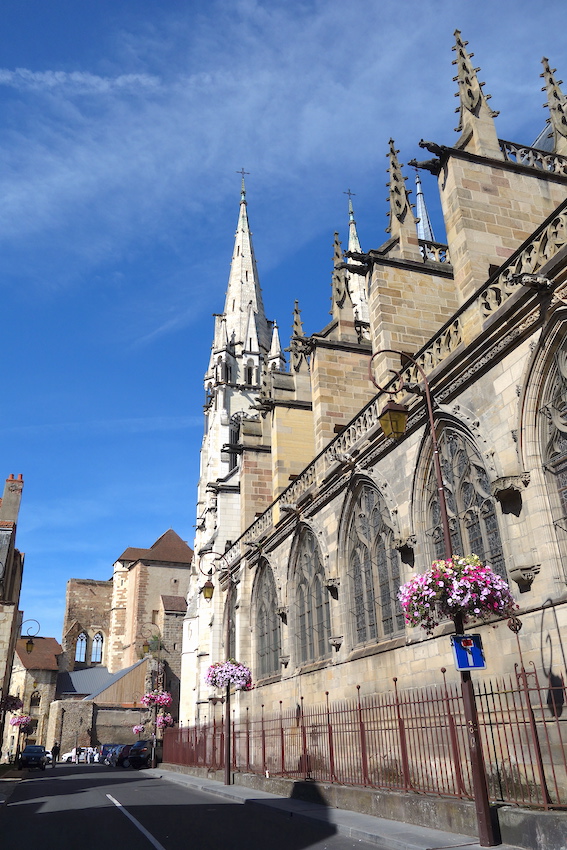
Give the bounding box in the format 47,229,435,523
224,174,270,351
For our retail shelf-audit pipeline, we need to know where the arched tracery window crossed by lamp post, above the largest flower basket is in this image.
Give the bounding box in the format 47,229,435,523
426,427,506,577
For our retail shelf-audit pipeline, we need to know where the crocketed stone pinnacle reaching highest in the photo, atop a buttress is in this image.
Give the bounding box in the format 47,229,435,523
453,30,504,159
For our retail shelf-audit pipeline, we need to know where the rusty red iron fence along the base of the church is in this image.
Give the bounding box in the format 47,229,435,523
164,666,567,809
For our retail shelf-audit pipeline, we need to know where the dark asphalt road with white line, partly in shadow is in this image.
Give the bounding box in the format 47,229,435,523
0,764,382,850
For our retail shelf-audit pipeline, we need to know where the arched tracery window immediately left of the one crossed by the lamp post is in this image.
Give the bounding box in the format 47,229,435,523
347,484,404,643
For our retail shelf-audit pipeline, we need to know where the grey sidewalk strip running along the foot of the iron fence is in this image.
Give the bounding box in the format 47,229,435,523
148,767,528,850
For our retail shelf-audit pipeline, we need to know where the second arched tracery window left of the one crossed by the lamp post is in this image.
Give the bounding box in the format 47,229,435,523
294,529,331,664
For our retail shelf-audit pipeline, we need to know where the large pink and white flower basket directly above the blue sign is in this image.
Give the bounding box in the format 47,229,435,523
398,555,519,634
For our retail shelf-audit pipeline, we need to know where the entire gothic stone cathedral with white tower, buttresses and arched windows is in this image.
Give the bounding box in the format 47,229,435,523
180,32,567,725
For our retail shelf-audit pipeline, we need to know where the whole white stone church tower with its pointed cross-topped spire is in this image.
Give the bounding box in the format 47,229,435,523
180,181,272,719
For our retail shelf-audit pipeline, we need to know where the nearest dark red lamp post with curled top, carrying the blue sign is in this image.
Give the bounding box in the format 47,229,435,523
368,348,500,847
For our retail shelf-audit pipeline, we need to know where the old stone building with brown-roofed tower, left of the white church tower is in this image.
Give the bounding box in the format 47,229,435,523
31,529,193,751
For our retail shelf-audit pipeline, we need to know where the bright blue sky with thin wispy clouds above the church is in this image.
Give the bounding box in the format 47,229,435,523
0,0,567,638
